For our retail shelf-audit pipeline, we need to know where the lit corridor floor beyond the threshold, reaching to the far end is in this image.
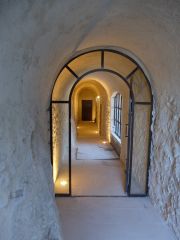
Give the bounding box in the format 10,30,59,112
72,122,125,196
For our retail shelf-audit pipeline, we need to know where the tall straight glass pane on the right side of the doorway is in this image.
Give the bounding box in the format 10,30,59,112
130,105,151,194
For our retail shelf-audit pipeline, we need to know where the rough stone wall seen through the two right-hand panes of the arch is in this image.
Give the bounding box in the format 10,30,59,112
130,70,151,194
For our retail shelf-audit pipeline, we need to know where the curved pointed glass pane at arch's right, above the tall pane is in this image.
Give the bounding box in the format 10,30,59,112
131,70,151,102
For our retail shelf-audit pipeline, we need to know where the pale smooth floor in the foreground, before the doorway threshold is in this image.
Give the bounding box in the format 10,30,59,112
56,197,175,240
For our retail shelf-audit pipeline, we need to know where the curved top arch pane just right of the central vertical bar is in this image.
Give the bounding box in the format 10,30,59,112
104,51,136,77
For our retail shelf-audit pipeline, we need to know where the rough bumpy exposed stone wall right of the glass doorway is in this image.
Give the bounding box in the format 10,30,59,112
149,92,180,239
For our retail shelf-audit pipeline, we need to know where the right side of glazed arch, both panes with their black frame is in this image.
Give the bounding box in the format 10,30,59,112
126,69,152,196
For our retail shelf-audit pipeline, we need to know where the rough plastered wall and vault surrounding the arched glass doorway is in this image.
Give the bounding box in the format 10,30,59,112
0,0,180,240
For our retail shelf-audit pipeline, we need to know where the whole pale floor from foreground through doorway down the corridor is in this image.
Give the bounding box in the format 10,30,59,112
56,123,174,240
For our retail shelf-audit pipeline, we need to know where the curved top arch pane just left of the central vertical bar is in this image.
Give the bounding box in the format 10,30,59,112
68,51,101,77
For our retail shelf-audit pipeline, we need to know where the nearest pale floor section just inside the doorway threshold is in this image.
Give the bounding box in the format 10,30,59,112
72,160,125,196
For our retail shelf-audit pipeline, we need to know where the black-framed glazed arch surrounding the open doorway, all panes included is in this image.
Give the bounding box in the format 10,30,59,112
50,48,153,196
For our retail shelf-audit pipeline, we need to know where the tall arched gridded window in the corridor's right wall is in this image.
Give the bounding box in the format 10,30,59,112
113,93,122,138
